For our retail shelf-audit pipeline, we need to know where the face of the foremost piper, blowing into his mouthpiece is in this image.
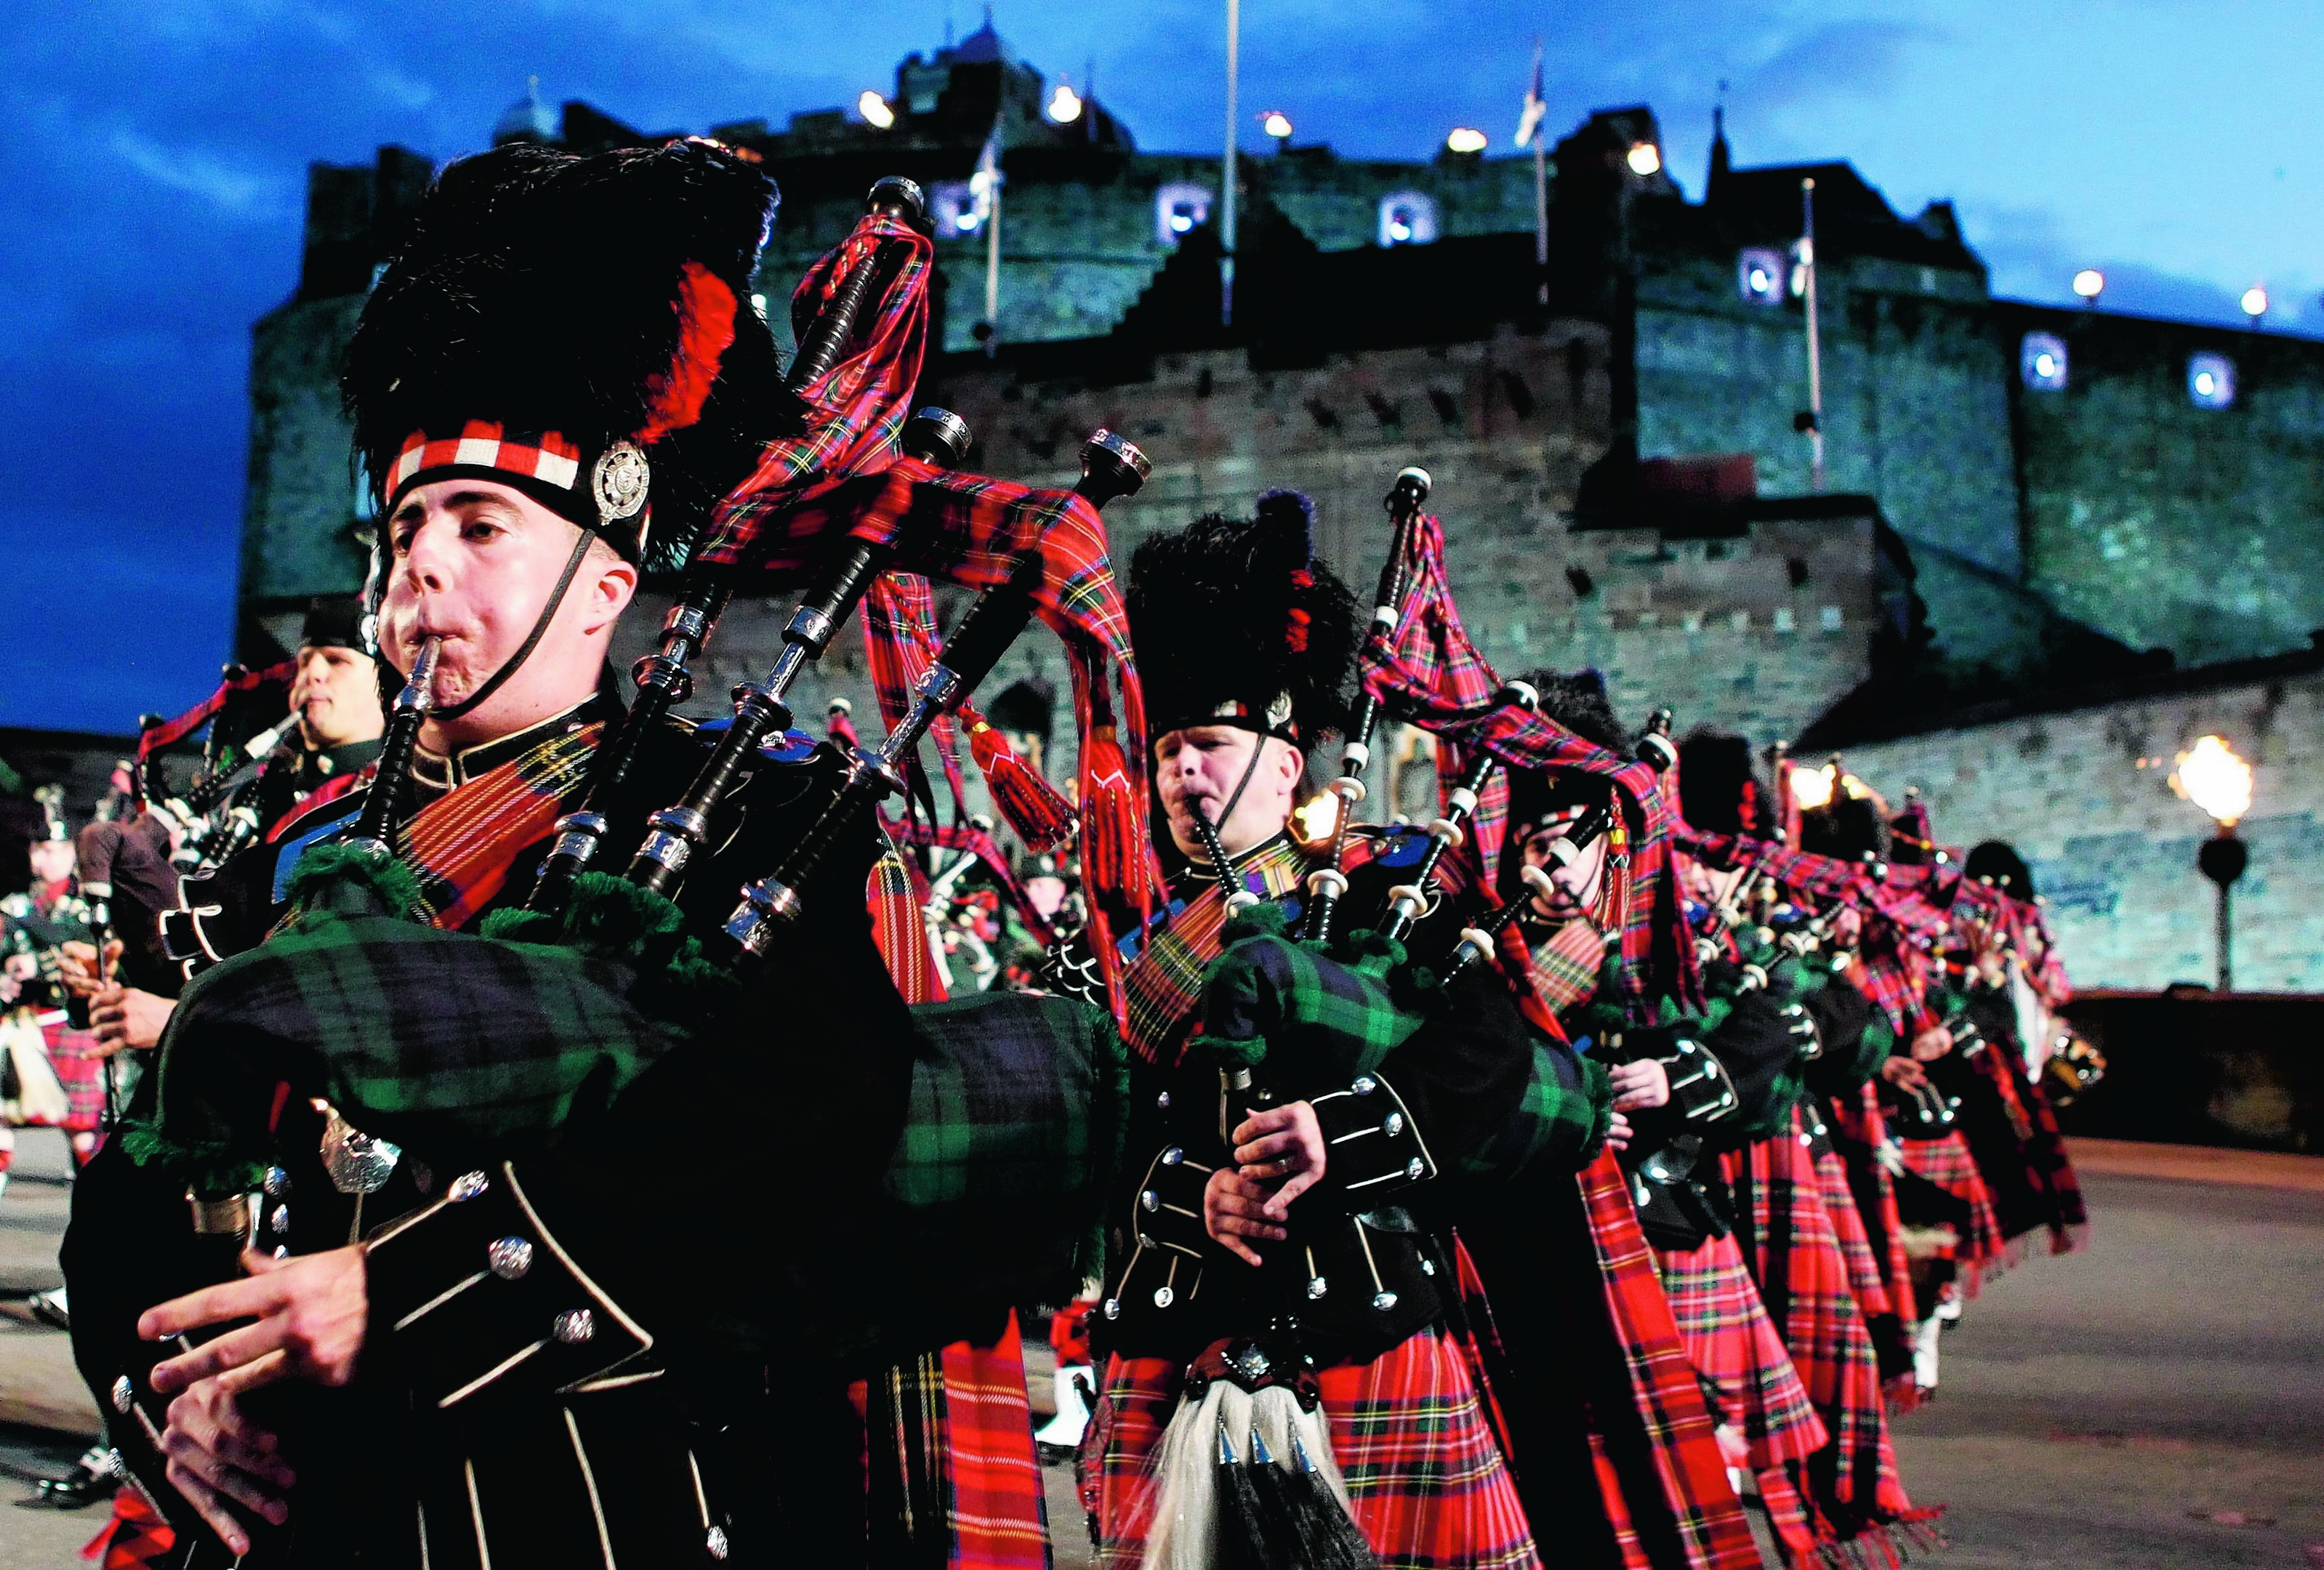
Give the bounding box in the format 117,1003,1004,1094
379,478,637,746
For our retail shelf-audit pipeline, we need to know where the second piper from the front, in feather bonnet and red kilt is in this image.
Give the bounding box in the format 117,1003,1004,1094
1064,492,1620,1568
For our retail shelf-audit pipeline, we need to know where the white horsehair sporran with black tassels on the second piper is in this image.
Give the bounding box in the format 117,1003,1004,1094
1143,1380,1378,1570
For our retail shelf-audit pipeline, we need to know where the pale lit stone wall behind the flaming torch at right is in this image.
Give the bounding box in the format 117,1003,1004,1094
1848,667,2324,991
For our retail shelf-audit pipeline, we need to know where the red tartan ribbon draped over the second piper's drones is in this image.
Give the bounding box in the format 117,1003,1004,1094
1357,515,1697,1008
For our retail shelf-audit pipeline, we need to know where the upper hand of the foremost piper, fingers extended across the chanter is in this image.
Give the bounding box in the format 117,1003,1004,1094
137,1245,369,1396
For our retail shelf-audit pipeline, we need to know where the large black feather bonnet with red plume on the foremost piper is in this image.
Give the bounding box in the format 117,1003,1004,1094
339,142,795,580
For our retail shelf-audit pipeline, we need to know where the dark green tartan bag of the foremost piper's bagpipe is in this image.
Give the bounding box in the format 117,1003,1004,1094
123,848,1127,1337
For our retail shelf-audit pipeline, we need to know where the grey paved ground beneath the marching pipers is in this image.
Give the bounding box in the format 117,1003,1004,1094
0,1135,2324,1570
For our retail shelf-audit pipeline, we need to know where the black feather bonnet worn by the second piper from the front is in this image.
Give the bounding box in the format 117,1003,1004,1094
1130,490,1359,746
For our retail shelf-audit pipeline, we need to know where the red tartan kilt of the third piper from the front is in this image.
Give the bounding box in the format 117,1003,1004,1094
1657,1233,1831,1473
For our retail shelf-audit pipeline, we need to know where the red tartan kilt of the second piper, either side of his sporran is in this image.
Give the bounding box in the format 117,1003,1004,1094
1081,1331,1541,1570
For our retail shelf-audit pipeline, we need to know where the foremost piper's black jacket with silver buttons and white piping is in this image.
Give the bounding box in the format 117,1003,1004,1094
65,701,911,1570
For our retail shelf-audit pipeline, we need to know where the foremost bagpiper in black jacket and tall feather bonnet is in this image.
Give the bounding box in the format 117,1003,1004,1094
65,142,1129,1566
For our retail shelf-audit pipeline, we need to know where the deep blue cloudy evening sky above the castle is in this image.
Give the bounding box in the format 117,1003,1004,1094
0,0,2324,734
